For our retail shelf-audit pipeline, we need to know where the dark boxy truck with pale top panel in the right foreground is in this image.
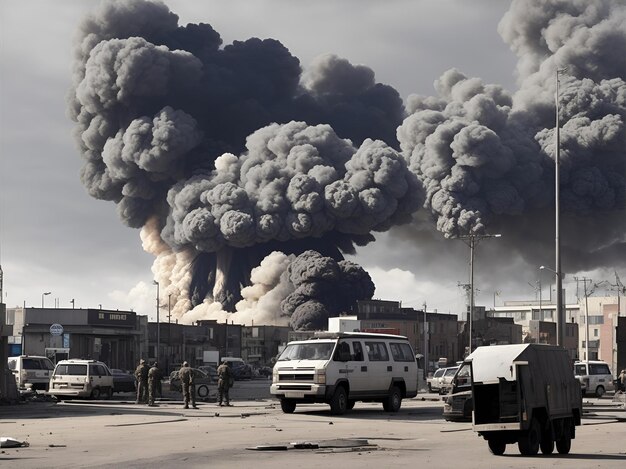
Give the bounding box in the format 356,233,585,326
465,344,582,456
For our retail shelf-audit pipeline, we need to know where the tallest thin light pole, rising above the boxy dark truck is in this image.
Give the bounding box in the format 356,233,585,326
554,68,567,346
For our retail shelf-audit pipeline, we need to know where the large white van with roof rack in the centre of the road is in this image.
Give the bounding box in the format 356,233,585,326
270,332,417,414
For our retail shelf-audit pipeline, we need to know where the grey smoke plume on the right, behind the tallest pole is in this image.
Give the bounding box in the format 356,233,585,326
398,0,626,268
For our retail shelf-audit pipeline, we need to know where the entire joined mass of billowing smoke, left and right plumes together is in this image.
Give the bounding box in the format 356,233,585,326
69,0,626,328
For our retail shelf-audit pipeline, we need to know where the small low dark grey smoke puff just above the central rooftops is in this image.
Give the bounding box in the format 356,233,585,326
280,251,375,330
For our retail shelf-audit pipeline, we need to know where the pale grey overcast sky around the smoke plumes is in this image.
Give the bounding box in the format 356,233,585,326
0,0,613,318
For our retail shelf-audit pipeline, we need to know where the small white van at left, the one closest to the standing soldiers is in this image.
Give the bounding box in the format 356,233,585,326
48,360,113,400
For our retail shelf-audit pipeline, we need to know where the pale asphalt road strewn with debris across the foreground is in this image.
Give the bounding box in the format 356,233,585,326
0,380,626,469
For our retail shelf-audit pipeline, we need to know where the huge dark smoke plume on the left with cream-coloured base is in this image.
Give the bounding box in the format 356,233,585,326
69,0,414,324
